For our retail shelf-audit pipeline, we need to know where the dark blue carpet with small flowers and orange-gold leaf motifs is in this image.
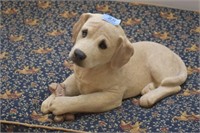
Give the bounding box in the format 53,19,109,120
0,0,200,133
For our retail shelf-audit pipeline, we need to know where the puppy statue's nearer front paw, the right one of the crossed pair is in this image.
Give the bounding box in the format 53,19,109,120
49,97,66,115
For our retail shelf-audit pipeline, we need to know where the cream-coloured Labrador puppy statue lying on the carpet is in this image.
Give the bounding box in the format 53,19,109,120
41,13,187,115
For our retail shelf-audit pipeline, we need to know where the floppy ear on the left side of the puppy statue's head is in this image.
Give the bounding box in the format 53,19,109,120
72,13,92,43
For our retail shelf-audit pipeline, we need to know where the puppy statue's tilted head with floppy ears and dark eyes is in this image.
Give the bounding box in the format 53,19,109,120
69,13,134,68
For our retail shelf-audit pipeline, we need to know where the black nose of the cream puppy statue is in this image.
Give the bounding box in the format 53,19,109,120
71,49,87,65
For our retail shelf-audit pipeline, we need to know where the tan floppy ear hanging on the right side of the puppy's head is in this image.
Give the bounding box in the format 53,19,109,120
111,37,134,69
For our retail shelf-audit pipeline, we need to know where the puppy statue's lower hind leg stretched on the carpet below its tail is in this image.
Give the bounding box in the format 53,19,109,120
140,86,181,107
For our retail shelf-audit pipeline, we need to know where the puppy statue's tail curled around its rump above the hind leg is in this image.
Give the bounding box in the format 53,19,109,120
161,57,187,86
